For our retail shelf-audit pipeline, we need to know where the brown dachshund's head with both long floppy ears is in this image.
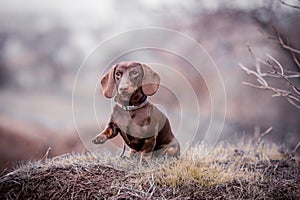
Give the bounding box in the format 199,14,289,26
101,62,160,101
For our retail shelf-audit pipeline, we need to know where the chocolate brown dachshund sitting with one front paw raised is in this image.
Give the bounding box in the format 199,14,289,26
93,62,180,161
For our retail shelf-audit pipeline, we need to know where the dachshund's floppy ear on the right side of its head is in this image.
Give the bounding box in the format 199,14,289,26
142,64,160,96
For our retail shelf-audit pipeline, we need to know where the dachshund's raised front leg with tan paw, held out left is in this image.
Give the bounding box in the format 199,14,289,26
92,122,119,144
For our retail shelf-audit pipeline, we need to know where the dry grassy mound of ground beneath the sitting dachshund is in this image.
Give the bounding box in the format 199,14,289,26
0,139,300,199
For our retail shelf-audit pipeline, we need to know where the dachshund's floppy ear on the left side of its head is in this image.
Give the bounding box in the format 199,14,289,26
101,65,117,98
